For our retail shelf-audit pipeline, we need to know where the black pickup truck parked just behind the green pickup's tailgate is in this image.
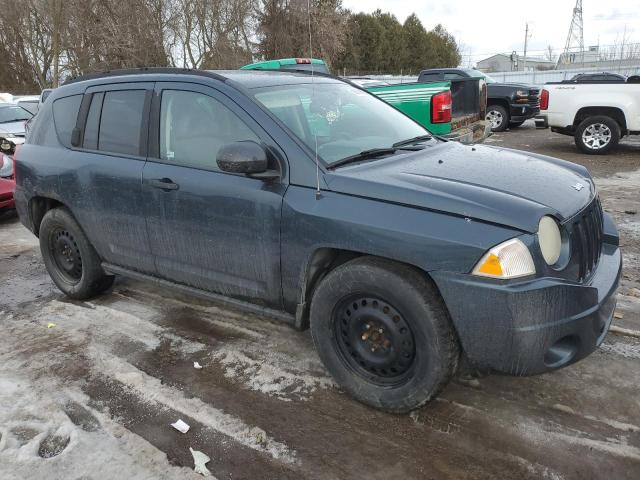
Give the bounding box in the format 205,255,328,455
418,68,540,132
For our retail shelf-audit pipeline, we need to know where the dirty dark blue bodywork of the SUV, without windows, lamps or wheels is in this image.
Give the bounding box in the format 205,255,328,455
15,70,621,375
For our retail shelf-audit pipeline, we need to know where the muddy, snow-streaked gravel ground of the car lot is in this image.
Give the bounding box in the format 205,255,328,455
0,122,640,480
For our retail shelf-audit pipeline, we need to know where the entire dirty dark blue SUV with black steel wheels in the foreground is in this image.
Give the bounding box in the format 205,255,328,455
15,69,621,412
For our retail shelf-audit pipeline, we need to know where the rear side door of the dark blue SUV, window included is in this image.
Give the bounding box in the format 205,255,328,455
71,82,155,273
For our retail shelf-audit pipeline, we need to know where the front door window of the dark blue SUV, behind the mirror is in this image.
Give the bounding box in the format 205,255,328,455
160,90,260,171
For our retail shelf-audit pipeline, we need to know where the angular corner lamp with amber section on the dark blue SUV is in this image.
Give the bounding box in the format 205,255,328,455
473,238,536,279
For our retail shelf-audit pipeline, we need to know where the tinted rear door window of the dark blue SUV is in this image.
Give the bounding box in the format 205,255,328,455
98,90,146,155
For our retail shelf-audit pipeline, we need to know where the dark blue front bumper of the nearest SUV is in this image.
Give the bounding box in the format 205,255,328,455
432,236,622,375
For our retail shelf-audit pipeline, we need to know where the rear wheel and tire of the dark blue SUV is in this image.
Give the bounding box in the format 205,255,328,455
39,208,114,300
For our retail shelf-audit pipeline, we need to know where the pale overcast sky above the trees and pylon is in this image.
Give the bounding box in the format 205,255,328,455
343,0,640,63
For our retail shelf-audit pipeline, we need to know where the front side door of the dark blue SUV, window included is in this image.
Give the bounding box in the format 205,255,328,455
143,82,286,306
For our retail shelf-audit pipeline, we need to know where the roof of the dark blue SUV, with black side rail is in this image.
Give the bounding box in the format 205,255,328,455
65,68,341,89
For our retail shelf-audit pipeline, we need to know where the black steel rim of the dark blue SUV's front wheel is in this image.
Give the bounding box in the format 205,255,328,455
332,295,416,386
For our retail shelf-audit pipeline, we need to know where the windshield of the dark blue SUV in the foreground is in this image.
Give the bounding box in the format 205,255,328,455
255,83,429,166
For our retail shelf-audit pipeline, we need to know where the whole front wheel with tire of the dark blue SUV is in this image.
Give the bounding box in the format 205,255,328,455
311,257,460,413
